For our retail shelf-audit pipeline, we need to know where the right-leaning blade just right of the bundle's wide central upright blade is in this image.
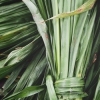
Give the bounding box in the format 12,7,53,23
69,12,88,77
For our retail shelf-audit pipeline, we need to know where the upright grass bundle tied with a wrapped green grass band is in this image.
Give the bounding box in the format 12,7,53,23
23,0,98,100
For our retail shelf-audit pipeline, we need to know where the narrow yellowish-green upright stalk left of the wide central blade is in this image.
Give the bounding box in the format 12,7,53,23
52,0,60,77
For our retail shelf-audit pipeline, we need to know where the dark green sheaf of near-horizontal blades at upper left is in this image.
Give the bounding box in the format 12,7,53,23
0,2,39,58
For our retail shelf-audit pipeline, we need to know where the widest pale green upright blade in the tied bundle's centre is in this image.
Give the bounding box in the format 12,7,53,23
60,0,71,78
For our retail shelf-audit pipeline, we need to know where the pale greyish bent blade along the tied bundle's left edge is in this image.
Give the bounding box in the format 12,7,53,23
23,0,55,76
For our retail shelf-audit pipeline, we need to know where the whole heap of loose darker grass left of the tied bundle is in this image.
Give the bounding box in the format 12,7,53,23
0,0,47,100
